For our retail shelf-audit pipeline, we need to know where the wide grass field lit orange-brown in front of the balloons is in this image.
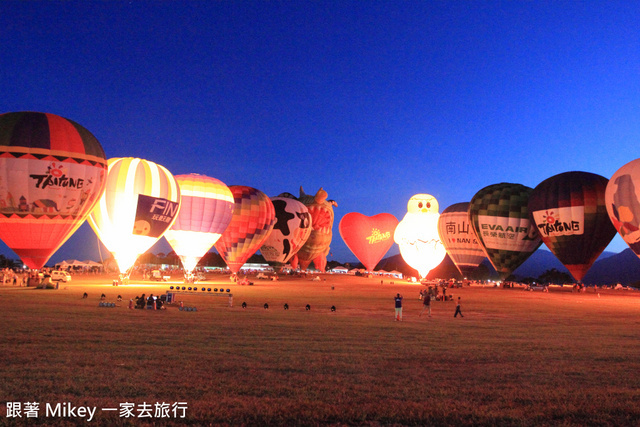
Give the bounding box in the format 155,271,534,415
0,275,640,426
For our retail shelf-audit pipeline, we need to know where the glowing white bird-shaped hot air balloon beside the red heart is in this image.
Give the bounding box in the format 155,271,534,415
394,194,447,278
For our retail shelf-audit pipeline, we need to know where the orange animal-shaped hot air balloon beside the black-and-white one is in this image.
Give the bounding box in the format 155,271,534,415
292,187,338,271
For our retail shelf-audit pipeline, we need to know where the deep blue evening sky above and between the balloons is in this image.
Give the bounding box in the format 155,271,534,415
0,0,640,261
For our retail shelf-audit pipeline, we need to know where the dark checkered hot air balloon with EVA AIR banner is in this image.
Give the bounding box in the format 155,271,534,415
469,182,542,279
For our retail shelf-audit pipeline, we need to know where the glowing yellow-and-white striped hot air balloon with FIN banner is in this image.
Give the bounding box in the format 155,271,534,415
88,157,180,275
